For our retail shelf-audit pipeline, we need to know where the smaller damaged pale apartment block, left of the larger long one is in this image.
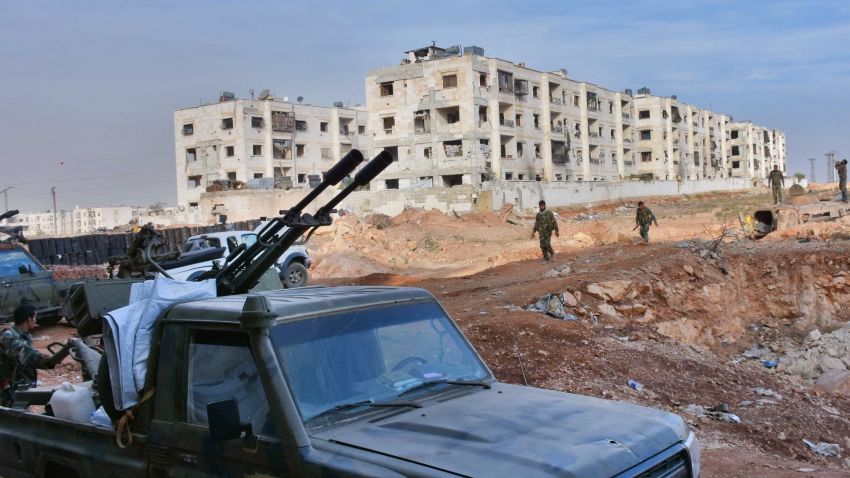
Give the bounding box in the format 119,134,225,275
174,90,369,208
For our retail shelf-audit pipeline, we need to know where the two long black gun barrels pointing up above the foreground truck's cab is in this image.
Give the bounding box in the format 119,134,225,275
215,149,393,296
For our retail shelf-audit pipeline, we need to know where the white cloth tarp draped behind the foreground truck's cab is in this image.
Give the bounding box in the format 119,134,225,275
103,277,216,410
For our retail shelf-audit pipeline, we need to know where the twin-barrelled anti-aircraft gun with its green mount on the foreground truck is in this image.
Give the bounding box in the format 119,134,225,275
66,149,392,336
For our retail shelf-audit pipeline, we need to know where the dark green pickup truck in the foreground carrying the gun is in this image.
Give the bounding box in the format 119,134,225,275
0,286,699,478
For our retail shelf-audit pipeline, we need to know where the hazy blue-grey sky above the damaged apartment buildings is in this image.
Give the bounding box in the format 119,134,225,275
0,0,850,211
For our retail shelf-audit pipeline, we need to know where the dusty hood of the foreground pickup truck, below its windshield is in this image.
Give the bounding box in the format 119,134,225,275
311,383,688,478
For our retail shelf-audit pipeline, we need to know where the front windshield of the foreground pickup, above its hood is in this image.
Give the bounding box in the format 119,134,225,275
271,302,490,422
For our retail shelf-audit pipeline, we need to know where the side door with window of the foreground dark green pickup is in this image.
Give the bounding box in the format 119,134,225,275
168,329,288,477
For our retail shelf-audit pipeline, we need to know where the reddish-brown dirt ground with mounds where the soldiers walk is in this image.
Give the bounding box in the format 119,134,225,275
21,186,850,477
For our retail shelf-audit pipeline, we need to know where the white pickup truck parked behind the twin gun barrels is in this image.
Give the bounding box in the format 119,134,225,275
166,231,312,288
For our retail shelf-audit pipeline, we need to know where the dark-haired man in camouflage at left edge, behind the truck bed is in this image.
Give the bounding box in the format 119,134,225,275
0,304,68,407
